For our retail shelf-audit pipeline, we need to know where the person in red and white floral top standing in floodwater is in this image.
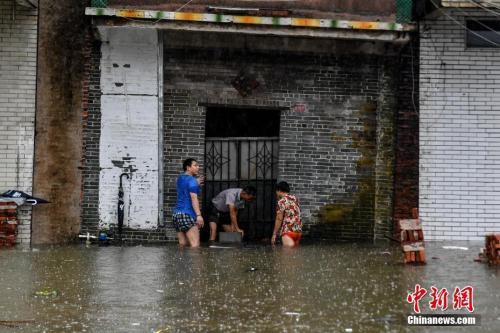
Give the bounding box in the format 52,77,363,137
271,182,302,247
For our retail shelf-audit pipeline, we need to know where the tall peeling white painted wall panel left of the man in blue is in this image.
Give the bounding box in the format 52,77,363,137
99,28,159,229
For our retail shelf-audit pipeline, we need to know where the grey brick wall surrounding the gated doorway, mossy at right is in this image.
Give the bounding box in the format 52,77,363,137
164,49,395,239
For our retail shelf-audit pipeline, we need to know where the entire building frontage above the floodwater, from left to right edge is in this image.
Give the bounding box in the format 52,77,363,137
8,0,500,243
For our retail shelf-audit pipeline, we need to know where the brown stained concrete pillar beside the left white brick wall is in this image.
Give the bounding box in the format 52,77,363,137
32,0,88,244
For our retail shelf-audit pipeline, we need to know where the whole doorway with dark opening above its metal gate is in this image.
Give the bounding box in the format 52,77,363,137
203,107,280,241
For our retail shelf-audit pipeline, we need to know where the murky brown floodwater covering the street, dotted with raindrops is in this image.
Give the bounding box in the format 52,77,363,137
0,242,500,333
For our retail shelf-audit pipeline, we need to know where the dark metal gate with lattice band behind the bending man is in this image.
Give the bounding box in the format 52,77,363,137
203,137,279,240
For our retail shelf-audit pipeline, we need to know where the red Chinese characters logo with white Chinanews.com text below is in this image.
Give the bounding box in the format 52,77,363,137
406,284,481,326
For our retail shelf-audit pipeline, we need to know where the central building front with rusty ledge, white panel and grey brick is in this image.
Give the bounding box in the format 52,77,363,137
81,1,418,241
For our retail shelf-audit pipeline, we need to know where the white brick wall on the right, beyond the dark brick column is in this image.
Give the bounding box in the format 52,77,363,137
419,9,500,240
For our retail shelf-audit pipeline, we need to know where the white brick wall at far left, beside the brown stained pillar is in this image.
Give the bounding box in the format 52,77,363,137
0,0,37,244
